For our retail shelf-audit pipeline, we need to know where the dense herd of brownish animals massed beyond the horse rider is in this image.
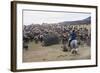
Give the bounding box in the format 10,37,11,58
23,24,91,50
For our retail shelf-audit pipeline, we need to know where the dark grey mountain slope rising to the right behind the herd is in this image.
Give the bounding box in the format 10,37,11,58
59,17,91,25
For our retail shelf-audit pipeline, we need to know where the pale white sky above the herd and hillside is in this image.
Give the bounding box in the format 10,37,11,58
23,10,91,25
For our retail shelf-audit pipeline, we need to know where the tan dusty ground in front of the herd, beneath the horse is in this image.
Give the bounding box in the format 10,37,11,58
23,42,91,62
